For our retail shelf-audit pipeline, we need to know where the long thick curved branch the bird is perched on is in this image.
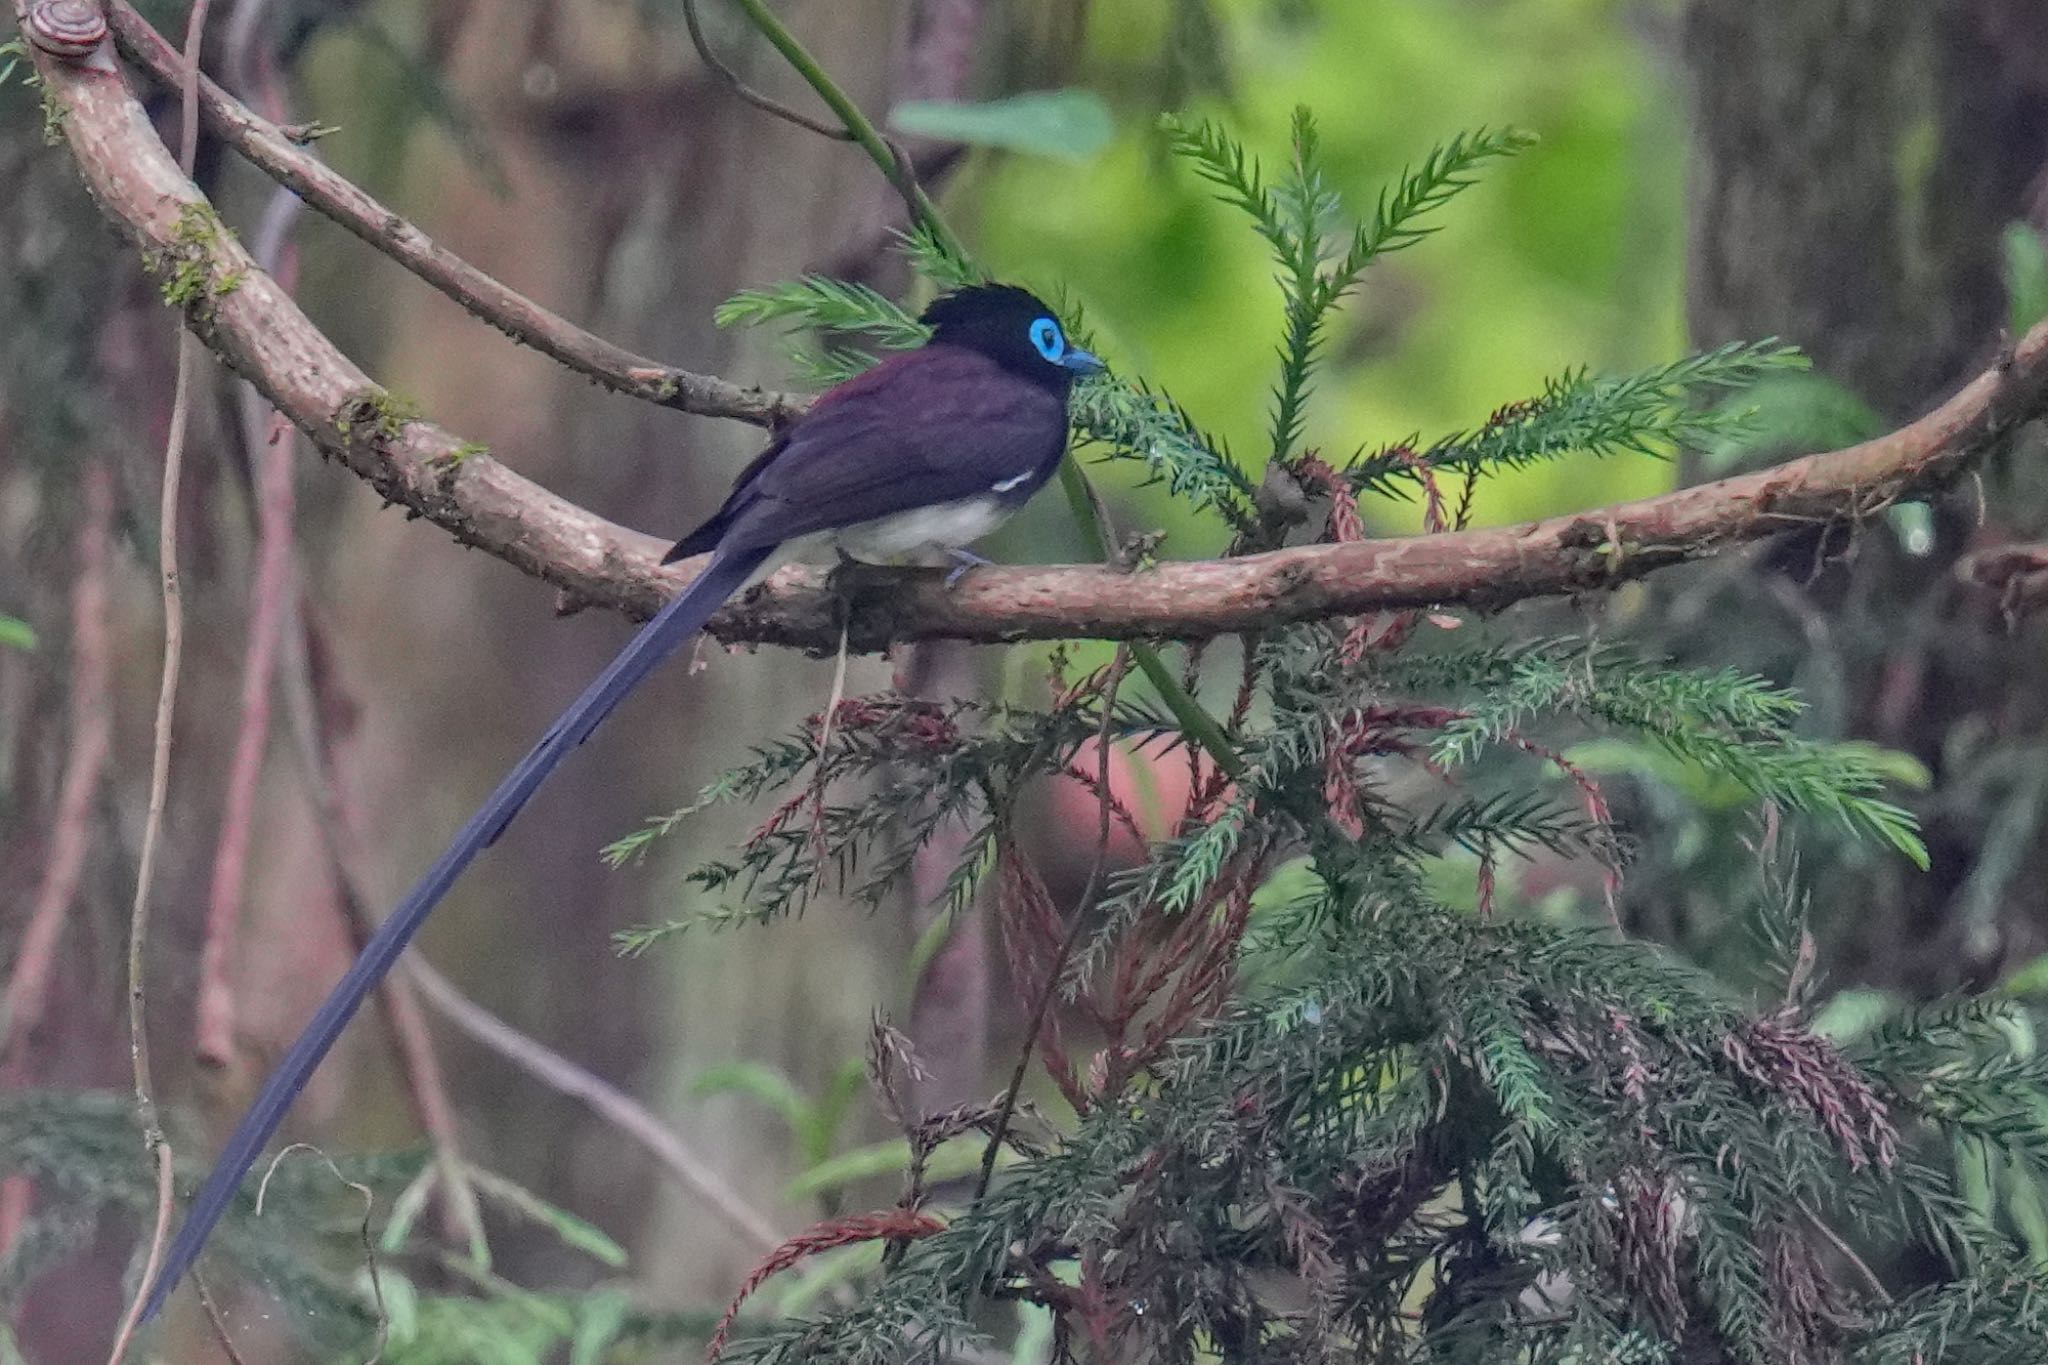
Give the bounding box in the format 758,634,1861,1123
28,30,2048,651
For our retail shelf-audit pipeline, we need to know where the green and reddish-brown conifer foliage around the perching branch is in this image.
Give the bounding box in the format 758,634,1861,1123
659,113,2048,1365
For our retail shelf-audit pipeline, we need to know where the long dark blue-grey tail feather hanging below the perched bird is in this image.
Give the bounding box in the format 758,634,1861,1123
141,551,770,1320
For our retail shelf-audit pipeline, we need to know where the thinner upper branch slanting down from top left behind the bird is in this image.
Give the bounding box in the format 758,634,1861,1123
109,0,807,426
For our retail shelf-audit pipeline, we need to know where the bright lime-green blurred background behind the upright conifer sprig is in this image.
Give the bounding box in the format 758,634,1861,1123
967,0,1686,530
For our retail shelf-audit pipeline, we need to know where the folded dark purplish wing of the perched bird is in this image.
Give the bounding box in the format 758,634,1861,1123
719,346,1067,551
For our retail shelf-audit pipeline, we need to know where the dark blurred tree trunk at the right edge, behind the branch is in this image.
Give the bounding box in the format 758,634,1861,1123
1686,0,2048,995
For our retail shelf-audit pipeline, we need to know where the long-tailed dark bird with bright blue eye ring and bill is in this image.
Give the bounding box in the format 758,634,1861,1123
141,284,1104,1320
